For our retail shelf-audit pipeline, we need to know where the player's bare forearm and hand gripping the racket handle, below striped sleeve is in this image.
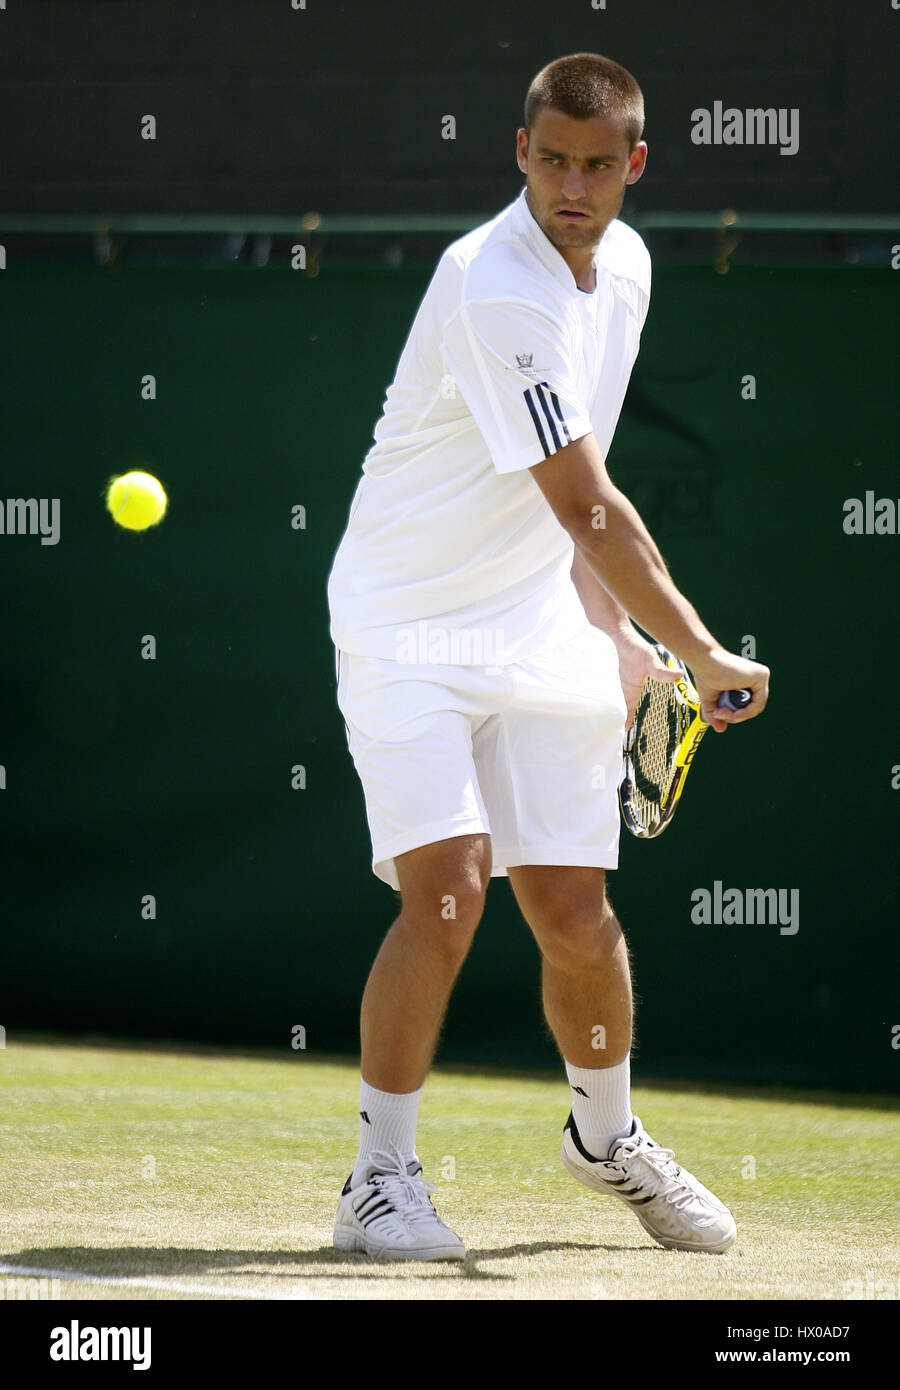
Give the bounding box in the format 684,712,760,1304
530,434,769,733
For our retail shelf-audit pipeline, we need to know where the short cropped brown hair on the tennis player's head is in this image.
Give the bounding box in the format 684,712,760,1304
524,53,644,149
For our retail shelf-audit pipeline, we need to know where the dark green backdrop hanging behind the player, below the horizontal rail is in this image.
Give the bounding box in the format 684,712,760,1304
0,261,900,1090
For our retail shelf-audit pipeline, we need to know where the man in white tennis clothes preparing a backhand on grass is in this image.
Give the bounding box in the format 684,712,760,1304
328,53,769,1259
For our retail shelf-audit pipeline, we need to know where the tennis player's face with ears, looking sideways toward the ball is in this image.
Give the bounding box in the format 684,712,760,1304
516,106,647,247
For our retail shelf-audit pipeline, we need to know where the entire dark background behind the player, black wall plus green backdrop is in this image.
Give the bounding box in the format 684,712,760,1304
0,0,900,1090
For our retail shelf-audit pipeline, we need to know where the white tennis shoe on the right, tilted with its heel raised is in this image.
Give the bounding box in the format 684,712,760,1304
562,1115,737,1255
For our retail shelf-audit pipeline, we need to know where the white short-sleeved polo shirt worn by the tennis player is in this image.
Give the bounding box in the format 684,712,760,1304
328,188,650,666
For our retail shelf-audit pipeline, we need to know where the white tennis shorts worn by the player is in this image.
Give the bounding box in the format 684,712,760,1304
335,626,626,888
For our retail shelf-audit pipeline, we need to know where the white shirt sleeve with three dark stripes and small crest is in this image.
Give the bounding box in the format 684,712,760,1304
441,299,593,473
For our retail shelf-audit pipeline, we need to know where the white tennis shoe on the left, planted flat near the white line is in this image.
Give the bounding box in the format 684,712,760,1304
334,1148,466,1259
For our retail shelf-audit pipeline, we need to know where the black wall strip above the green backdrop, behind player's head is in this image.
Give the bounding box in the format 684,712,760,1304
0,0,900,215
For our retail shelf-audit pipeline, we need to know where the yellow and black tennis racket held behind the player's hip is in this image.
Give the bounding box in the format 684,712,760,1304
619,642,751,840
